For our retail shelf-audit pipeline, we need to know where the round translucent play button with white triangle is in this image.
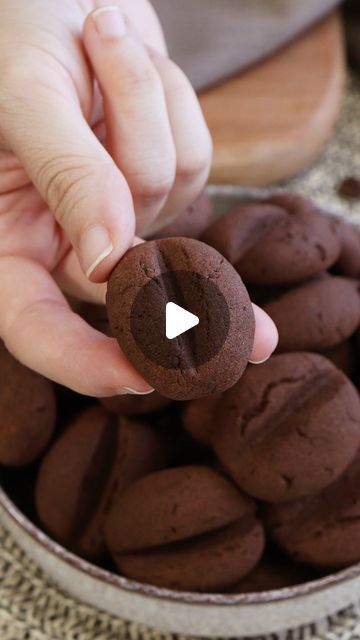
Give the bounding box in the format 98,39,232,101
129,269,230,371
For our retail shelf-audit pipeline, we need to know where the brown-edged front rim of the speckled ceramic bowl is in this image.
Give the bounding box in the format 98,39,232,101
0,486,360,607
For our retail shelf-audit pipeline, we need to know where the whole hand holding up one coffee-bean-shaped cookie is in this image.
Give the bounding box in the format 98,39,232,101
0,0,276,396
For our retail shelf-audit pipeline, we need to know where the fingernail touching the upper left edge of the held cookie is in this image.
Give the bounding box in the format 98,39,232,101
79,224,114,278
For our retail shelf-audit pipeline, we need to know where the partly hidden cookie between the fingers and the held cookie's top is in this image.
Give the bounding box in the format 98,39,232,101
149,192,213,240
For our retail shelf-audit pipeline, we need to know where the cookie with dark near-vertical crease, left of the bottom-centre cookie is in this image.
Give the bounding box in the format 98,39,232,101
36,406,163,558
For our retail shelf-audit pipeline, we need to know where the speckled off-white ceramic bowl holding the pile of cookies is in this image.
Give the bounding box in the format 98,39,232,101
0,187,360,638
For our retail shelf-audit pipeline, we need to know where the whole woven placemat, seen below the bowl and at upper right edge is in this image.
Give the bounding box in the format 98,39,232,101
0,76,360,640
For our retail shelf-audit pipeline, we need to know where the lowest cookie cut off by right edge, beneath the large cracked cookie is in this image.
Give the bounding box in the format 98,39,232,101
267,455,360,569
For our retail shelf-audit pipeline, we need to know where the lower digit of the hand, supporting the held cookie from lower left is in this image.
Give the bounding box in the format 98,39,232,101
0,256,152,397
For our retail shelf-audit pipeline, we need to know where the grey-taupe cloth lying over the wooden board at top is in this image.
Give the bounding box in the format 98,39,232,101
152,0,340,88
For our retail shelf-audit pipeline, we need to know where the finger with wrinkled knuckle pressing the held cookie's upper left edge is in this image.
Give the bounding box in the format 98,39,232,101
0,86,135,282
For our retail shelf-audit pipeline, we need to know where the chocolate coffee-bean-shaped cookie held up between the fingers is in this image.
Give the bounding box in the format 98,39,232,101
107,238,255,400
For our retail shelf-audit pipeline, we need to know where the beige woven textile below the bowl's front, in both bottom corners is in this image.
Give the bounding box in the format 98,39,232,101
0,523,360,640
